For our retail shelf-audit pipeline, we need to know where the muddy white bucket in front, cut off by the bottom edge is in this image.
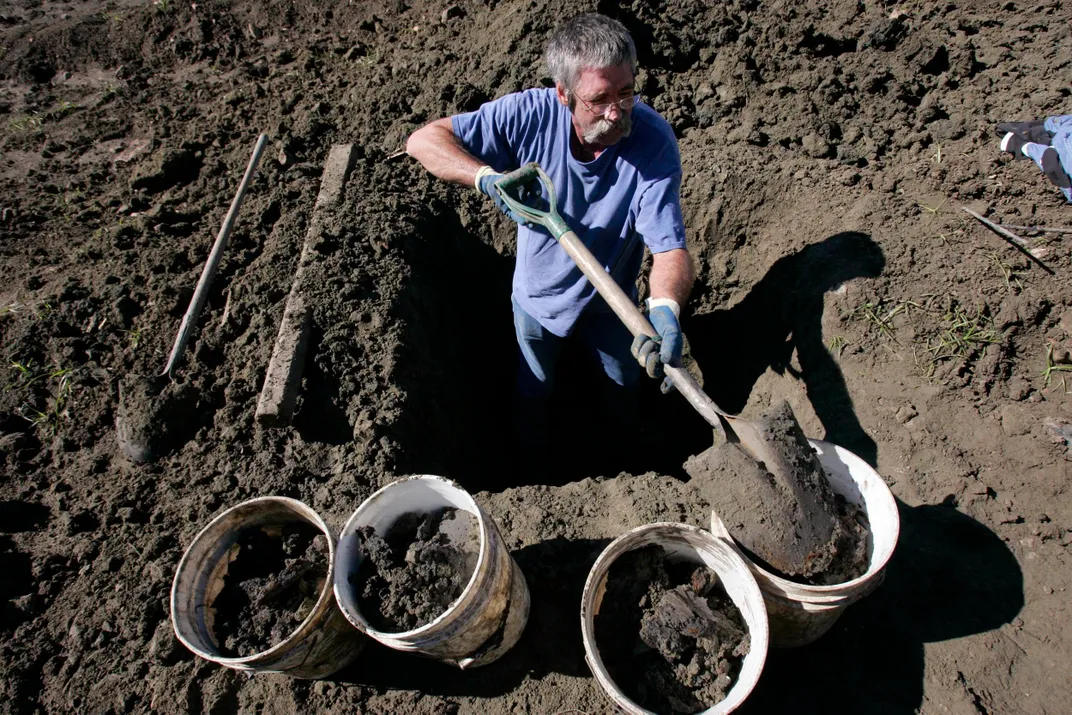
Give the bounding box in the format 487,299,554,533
581,523,769,715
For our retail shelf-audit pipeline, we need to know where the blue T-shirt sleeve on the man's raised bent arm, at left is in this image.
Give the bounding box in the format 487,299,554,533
450,93,525,172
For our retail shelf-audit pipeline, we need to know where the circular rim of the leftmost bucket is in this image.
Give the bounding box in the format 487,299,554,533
168,496,336,670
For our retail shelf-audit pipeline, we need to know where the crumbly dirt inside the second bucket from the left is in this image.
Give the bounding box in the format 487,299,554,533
349,507,479,632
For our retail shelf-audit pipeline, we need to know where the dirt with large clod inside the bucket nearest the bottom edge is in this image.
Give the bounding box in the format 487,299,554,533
595,546,751,713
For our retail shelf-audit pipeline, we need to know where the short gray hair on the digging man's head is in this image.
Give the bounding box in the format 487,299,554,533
547,13,637,91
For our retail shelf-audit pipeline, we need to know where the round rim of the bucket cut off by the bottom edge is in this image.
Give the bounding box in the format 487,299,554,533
581,521,771,715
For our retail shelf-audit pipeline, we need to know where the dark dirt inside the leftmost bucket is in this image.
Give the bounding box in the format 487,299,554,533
210,522,328,658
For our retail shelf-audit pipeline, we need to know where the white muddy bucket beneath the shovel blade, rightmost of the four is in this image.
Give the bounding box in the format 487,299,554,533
711,440,900,647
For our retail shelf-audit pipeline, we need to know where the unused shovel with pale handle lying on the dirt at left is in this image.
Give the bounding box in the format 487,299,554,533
116,134,268,463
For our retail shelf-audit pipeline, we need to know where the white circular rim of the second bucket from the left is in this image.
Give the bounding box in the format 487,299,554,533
331,474,491,638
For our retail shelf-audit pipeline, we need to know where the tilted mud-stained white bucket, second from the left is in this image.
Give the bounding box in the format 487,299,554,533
334,475,528,669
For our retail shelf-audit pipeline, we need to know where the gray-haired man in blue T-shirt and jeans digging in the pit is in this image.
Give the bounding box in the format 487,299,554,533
406,14,694,456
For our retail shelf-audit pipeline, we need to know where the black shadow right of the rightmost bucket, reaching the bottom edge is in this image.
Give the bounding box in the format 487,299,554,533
739,502,1024,715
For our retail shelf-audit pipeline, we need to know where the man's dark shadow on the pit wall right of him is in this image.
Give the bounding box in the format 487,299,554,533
682,232,885,466
